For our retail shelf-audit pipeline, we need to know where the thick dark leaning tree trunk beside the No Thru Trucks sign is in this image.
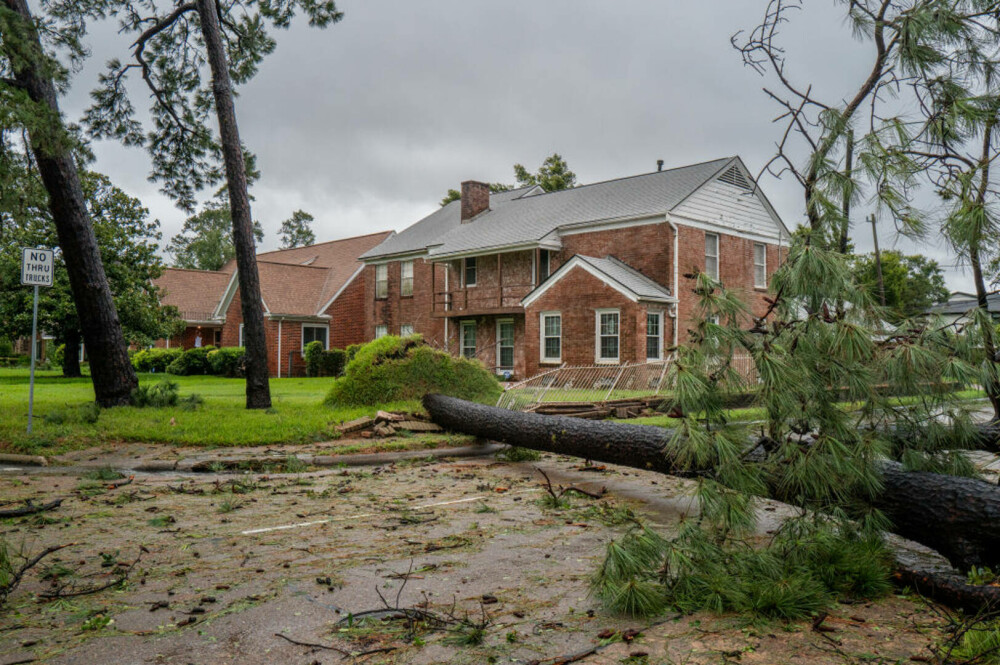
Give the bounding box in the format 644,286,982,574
3,0,139,407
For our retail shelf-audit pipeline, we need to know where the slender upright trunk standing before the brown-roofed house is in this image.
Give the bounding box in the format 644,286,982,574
198,0,271,409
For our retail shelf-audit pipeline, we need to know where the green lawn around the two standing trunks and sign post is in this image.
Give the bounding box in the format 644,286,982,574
0,369,420,455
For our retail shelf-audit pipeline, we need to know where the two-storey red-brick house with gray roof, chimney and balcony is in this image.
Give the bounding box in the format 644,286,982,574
361,157,789,377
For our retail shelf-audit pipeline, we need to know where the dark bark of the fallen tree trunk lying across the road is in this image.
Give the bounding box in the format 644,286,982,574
423,395,1000,570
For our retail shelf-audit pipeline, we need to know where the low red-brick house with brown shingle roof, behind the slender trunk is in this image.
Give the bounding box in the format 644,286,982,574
155,232,390,377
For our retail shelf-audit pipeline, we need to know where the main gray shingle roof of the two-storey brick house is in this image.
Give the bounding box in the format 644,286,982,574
362,157,736,259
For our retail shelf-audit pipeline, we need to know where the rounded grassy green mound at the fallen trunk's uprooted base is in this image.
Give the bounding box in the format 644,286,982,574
326,335,501,405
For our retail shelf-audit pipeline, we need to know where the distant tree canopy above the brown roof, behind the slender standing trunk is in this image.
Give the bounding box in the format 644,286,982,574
167,202,264,270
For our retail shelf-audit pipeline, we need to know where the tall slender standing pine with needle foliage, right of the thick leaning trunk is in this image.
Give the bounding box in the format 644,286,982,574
77,0,343,409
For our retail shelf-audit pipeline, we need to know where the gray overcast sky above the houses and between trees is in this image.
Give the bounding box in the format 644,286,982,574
62,0,969,290
